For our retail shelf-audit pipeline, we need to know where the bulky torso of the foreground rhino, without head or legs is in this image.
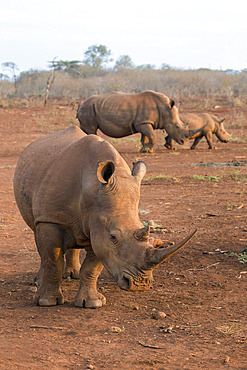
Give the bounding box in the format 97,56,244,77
14,127,130,235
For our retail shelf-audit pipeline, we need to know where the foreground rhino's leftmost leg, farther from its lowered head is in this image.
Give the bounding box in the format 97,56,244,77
34,223,64,306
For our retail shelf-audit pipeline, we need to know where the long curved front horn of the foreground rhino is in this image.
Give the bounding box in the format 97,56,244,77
145,229,197,268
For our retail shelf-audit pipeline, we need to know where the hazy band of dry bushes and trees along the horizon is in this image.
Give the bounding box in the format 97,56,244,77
0,45,247,100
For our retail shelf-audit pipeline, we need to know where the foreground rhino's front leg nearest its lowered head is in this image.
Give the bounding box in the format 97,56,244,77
75,248,106,308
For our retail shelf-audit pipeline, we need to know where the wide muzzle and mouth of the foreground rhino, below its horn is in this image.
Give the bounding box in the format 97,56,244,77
117,273,153,291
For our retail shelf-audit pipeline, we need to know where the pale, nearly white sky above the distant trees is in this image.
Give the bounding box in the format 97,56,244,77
0,0,247,76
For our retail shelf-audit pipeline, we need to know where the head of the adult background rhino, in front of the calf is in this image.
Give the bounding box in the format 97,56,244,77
164,99,208,145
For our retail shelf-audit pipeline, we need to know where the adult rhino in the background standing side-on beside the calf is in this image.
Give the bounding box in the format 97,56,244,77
76,91,206,153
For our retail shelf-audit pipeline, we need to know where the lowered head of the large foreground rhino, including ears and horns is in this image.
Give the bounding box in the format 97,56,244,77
90,161,195,291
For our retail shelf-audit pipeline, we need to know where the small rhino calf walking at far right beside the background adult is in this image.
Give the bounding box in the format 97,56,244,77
165,113,231,150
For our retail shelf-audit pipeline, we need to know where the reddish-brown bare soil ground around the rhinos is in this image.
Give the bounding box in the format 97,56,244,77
0,97,247,369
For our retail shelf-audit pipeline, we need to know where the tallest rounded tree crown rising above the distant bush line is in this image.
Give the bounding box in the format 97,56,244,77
83,45,112,68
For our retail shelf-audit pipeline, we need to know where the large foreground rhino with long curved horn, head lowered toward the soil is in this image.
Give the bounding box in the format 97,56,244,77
14,126,198,308
